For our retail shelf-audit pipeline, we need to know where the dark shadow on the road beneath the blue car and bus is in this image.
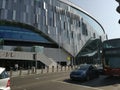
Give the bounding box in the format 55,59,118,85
64,76,120,87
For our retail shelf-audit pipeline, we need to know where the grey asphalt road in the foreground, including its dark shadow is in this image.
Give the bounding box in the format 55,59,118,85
11,72,120,90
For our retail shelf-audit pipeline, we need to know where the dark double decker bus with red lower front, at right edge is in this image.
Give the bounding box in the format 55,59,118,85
102,38,120,76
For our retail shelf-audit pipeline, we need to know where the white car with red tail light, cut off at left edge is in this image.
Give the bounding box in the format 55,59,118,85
0,67,11,90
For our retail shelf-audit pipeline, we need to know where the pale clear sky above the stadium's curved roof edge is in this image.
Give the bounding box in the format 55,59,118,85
69,0,120,39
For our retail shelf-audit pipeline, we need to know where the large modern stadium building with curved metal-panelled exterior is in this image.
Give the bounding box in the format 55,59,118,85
0,0,107,68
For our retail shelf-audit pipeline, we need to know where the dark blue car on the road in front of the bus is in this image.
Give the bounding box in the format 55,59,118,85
70,64,99,81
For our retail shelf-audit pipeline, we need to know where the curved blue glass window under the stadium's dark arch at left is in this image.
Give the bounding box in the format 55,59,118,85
0,26,50,43
